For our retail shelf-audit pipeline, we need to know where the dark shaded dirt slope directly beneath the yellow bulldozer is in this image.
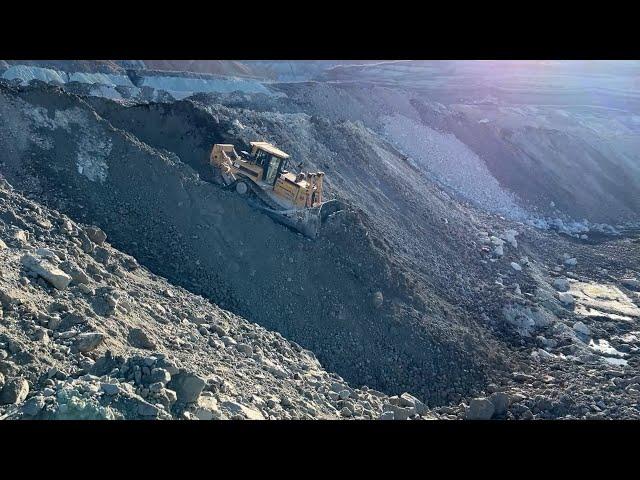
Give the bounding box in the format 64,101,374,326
0,85,504,404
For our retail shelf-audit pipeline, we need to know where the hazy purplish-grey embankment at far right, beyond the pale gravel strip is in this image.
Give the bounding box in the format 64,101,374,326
413,100,640,224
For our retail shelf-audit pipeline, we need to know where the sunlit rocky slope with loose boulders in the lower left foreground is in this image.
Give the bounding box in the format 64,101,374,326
0,180,436,420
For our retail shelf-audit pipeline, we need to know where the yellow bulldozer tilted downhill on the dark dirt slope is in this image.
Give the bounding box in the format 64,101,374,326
210,142,343,238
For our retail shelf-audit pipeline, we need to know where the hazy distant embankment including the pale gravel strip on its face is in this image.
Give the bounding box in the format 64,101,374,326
224,78,640,231
